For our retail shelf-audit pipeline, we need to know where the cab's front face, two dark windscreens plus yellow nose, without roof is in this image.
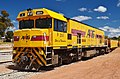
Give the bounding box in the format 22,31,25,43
14,18,52,47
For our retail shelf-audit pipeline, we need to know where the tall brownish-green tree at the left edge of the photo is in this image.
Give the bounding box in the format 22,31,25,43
0,10,14,36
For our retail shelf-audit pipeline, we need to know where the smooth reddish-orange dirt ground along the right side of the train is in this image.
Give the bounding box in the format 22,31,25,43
26,48,120,79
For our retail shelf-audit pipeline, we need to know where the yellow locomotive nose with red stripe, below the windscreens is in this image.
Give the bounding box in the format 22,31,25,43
14,29,49,47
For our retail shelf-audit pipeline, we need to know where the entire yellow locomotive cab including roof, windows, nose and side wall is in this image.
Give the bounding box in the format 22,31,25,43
14,8,67,47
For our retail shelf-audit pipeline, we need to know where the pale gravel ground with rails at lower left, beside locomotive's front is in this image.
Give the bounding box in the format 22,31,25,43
0,52,39,79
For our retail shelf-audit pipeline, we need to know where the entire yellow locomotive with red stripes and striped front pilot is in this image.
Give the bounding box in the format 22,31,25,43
12,8,116,70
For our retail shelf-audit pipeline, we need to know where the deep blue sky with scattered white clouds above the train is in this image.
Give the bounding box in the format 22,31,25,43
0,0,120,37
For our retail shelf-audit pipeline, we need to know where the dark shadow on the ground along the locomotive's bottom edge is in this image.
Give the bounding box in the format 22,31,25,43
7,48,116,72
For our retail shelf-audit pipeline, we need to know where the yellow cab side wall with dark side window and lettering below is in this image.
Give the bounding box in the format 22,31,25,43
53,19,67,46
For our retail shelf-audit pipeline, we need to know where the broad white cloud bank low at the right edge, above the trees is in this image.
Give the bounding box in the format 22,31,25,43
99,26,120,37
